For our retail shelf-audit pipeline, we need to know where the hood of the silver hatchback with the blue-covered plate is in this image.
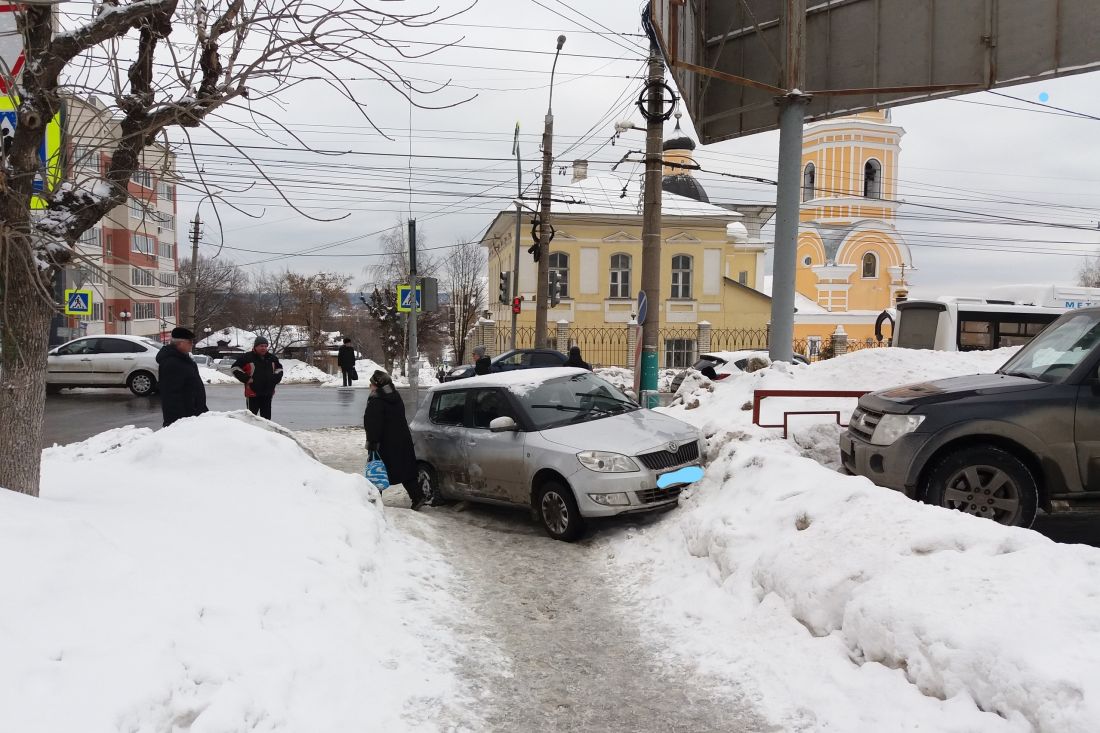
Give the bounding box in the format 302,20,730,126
541,409,699,456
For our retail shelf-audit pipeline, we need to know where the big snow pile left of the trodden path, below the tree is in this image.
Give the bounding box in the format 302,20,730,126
0,413,477,733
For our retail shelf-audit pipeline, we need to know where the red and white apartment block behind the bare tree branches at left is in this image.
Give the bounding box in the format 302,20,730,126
61,97,179,340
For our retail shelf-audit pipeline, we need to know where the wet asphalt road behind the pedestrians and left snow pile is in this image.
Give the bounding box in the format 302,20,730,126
42,384,426,447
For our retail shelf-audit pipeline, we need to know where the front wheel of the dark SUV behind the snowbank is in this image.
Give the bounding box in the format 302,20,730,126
924,446,1038,527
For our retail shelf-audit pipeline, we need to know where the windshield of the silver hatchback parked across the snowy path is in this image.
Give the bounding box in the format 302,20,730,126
514,372,640,430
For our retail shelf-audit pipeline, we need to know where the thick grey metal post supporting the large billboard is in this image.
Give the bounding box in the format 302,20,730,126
768,0,810,361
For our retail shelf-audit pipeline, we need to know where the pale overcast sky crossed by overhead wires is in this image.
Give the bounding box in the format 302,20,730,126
167,0,1100,295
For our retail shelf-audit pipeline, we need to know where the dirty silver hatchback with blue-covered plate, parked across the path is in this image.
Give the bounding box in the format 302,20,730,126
409,368,705,540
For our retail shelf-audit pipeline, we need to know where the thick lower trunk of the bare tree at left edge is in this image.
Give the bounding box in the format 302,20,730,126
0,228,51,496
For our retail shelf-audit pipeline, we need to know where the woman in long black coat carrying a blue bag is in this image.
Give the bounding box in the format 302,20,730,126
363,371,427,511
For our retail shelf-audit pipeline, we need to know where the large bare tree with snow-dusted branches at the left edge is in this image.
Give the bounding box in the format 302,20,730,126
0,0,462,495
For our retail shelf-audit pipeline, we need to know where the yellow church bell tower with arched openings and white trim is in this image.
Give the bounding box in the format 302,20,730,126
792,111,913,342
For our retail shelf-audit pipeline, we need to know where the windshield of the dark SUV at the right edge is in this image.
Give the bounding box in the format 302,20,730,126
998,311,1100,382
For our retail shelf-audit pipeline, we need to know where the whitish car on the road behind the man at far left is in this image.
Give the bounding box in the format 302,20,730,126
46,336,164,396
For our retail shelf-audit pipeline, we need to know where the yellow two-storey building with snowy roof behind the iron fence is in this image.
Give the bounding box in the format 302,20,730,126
482,138,771,367
